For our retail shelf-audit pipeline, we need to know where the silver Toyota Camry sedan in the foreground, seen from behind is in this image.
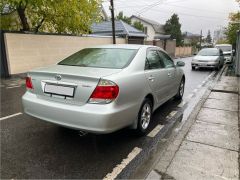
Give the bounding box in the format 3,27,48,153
22,45,185,134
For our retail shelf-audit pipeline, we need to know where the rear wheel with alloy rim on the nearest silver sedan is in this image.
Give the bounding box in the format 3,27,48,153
136,98,153,136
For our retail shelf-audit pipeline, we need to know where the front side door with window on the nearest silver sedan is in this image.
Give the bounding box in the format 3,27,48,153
158,50,180,97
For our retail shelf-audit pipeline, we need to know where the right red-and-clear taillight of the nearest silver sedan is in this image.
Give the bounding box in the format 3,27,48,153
88,80,119,104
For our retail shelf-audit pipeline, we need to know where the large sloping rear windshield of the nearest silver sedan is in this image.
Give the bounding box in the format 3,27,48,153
58,48,137,69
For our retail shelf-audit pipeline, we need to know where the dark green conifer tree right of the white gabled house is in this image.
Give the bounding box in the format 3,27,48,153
164,14,183,46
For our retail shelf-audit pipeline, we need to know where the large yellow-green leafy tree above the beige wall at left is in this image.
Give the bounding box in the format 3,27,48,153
0,0,101,34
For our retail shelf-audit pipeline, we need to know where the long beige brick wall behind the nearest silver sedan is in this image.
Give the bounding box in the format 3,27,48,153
4,33,126,74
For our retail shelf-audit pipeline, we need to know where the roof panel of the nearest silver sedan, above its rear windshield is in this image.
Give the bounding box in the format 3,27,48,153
87,44,161,49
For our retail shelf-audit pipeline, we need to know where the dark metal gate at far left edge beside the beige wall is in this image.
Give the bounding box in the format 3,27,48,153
0,30,9,78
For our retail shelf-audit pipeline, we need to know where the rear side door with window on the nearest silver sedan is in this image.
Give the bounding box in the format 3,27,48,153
145,48,169,104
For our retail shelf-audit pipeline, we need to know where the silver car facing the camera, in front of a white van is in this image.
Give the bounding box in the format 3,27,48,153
191,48,224,70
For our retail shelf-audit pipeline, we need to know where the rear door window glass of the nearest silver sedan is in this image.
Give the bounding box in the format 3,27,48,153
145,50,164,69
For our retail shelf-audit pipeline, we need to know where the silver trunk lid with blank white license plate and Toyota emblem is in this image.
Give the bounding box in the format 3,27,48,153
29,65,121,105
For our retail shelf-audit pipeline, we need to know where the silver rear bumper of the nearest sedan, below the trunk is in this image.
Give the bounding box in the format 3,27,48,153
22,92,138,134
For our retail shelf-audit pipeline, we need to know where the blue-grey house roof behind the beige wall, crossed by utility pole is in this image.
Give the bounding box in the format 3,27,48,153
91,20,147,37
